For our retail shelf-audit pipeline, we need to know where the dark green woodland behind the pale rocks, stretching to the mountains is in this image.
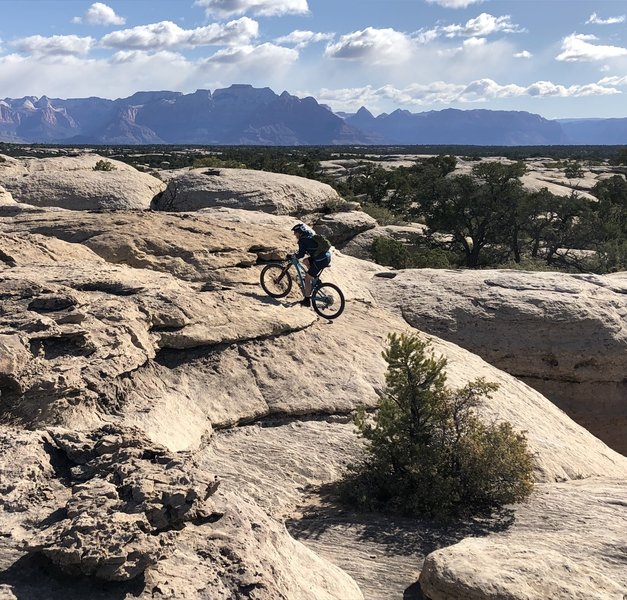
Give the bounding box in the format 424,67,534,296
0,144,627,273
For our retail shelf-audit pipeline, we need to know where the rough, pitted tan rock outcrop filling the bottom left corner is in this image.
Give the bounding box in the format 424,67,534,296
0,426,363,600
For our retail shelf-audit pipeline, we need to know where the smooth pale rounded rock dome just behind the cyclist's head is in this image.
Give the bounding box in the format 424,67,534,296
152,168,342,215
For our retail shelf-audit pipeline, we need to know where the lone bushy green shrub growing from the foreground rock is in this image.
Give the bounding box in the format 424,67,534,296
342,334,533,518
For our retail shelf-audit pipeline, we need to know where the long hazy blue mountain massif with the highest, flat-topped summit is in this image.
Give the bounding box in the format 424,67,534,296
0,85,377,145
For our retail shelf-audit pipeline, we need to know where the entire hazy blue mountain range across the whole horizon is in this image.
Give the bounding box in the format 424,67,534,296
0,85,627,146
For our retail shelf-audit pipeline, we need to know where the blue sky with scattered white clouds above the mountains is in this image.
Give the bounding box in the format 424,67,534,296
0,0,627,119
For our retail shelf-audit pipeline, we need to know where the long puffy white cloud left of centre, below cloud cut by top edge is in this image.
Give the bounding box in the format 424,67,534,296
100,17,259,50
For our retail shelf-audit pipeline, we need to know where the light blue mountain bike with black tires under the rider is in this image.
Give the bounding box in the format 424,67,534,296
260,256,346,319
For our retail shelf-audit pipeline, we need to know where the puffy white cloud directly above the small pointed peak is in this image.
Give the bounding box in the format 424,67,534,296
324,27,412,64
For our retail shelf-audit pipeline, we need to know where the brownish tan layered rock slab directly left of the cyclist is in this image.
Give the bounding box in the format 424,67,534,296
0,206,294,283
